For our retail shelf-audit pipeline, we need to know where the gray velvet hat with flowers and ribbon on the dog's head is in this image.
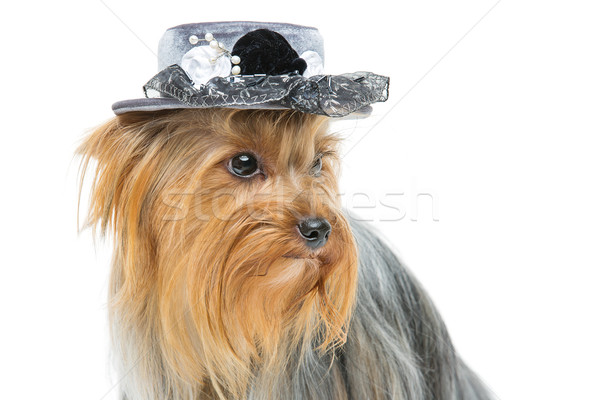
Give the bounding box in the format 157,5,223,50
112,22,389,117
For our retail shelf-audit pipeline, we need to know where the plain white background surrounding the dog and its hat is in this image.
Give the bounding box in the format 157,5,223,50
0,0,600,400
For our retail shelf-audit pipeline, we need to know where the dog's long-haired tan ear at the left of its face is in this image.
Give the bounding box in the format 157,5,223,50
77,113,169,312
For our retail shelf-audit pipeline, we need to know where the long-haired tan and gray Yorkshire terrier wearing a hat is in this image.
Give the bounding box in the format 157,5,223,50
78,108,493,400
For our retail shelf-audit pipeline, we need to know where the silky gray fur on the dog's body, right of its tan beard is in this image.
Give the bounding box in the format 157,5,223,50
249,222,494,400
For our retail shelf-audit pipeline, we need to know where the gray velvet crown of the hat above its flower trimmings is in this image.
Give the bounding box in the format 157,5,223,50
158,21,325,71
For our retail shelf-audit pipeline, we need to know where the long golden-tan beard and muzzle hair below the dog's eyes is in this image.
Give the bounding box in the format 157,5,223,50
157,186,356,397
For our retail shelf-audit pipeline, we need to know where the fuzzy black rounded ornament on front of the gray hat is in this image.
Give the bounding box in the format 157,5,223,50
231,29,307,75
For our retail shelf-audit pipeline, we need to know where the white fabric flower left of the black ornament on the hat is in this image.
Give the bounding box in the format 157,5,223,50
181,46,231,89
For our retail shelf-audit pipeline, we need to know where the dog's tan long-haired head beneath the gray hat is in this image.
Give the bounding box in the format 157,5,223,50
79,109,357,395
